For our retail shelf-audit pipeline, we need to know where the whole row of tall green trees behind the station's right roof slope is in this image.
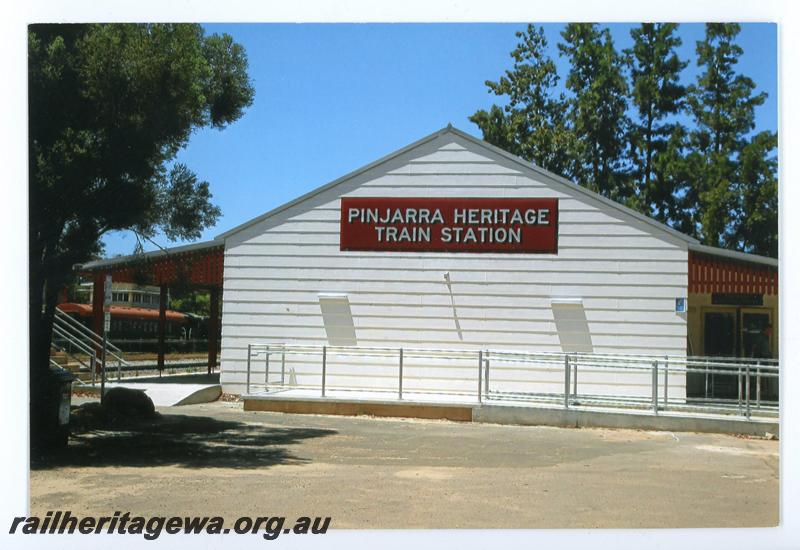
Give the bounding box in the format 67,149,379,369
470,23,778,257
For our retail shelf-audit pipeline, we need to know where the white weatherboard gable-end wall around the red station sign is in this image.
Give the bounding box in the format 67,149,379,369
221,132,688,404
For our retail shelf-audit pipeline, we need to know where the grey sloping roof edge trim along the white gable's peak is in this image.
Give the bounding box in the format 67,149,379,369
215,124,699,244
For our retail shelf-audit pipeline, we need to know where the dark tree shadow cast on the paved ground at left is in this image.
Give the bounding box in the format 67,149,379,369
31,414,338,470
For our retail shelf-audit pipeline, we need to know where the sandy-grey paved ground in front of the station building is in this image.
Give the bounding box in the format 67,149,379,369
30,402,779,528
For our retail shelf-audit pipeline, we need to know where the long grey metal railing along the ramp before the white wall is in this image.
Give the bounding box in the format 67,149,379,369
246,344,779,418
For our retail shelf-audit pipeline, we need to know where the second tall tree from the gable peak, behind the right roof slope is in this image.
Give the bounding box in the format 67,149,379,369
558,23,633,202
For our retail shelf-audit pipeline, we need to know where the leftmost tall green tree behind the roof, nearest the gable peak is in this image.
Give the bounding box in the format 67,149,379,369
469,25,574,177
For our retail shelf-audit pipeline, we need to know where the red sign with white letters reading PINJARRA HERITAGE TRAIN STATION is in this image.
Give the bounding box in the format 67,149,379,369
339,197,558,254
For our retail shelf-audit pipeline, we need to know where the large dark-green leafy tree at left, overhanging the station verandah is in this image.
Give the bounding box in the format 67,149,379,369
28,24,254,432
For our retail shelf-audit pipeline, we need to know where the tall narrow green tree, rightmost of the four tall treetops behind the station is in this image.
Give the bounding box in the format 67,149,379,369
688,23,777,249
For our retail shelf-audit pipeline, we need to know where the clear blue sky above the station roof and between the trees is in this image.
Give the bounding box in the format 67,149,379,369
104,23,778,256
